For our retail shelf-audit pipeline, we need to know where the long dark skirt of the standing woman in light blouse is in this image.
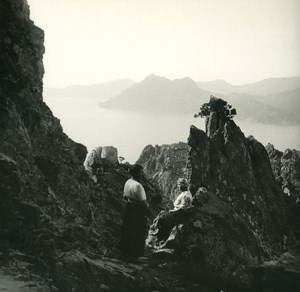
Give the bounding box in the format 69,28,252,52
120,202,147,257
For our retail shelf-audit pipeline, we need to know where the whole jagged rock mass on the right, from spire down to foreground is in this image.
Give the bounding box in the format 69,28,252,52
147,97,297,291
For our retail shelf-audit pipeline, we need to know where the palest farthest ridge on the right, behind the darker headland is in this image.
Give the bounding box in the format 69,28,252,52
197,77,300,95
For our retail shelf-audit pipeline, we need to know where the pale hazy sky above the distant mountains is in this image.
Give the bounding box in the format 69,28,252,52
28,0,300,87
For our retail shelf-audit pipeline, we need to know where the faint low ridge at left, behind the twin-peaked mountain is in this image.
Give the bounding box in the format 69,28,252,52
44,79,135,101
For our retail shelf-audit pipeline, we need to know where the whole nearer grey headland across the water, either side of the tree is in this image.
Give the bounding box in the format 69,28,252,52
99,75,300,125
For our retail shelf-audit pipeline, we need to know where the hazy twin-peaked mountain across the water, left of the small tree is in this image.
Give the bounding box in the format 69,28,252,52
100,75,210,112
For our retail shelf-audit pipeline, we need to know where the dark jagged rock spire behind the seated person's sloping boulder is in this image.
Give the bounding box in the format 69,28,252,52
188,116,292,246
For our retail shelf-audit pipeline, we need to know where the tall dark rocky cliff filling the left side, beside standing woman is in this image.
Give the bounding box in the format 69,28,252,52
0,0,159,291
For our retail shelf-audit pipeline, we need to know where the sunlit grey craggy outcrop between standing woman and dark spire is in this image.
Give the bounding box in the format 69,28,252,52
137,142,189,208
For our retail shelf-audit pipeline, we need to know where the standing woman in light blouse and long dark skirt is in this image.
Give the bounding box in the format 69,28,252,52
120,164,149,262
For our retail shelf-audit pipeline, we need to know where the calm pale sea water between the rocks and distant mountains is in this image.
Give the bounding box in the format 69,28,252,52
44,97,300,163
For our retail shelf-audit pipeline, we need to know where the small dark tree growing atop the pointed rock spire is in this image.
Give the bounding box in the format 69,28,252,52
194,95,236,121
